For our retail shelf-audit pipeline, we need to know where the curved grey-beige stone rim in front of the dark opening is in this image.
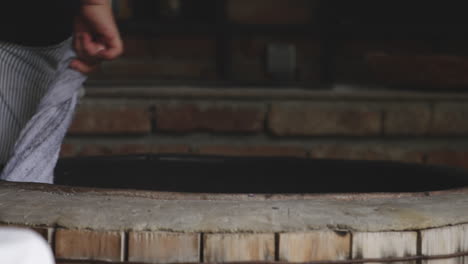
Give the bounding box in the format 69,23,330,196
0,183,468,233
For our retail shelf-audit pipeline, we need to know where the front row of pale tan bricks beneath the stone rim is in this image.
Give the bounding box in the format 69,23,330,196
3,225,468,264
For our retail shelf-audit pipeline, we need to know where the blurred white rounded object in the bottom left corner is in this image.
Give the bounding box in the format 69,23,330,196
0,228,55,264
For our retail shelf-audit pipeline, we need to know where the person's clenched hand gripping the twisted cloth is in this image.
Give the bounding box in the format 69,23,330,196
70,0,123,74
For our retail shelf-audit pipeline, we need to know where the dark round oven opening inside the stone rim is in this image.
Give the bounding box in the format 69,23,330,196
55,155,468,194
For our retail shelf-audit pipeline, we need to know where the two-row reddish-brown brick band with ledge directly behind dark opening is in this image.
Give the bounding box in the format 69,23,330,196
62,88,468,168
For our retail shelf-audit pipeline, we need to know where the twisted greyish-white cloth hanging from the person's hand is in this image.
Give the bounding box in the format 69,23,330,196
0,40,86,184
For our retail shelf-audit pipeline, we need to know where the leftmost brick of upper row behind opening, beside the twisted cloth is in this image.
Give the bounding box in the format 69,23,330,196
69,106,151,135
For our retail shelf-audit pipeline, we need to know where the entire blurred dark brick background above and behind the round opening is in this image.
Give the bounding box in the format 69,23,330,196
62,0,468,168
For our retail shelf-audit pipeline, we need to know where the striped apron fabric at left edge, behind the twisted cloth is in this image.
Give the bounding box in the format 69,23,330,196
0,40,74,164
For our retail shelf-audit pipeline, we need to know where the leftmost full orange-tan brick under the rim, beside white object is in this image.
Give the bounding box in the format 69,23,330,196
55,229,122,261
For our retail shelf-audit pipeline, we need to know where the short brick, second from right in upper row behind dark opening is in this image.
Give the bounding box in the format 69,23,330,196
384,104,431,135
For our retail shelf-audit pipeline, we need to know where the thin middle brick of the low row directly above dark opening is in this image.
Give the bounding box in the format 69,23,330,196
197,145,307,157
